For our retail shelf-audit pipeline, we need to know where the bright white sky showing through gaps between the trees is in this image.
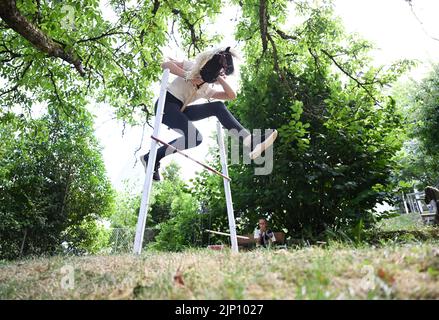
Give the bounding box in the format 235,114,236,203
95,0,439,191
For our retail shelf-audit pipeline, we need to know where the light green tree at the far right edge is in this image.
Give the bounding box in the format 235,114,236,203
394,65,439,191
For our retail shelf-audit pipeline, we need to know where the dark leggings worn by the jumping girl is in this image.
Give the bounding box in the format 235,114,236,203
154,92,250,162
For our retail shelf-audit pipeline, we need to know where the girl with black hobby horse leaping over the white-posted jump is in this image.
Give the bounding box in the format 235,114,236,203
140,47,277,181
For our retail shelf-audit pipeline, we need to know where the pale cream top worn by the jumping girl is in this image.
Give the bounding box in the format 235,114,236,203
168,60,215,105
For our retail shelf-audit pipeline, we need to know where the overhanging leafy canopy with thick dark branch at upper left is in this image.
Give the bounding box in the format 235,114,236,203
0,0,221,123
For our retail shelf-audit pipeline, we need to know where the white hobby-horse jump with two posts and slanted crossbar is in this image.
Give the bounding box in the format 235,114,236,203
133,69,238,254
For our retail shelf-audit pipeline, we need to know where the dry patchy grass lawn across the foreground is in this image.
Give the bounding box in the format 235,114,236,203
0,229,439,299
